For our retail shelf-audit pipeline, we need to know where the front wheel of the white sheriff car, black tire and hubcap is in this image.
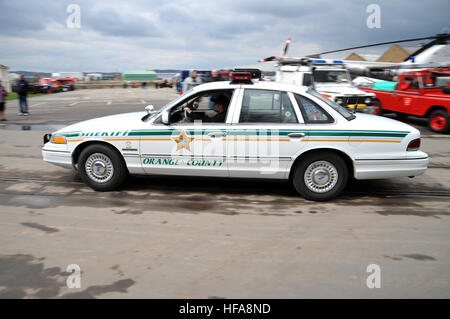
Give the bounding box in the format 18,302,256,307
78,144,128,192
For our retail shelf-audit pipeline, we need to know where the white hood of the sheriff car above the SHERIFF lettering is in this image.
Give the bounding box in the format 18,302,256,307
54,112,147,134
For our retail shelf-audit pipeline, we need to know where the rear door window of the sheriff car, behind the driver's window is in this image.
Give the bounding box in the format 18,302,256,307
239,90,298,123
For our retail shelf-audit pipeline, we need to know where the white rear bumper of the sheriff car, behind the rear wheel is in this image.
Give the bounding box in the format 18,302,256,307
354,157,430,179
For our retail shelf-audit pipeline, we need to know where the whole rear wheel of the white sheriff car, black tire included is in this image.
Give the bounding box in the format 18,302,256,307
292,151,349,201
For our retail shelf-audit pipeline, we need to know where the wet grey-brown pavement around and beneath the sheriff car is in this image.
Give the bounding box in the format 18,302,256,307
0,89,450,298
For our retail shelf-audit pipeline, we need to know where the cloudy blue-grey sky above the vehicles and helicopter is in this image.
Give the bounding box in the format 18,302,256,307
0,0,450,72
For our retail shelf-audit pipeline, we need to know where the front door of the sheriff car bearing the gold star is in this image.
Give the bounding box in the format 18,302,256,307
141,89,239,177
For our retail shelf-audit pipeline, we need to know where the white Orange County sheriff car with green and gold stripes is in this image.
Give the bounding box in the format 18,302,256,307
42,72,429,200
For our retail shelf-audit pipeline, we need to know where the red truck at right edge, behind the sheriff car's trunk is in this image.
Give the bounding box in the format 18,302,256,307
362,68,450,133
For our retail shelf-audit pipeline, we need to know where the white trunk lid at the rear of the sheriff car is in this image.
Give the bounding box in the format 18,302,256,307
349,113,419,133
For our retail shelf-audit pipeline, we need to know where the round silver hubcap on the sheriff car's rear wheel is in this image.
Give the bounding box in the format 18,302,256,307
304,161,339,193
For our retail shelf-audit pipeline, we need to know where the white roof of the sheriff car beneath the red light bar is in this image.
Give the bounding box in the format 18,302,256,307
194,81,308,93
